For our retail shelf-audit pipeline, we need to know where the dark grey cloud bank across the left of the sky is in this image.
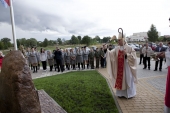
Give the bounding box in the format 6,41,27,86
0,1,98,34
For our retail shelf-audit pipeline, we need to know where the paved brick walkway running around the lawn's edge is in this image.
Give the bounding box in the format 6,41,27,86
32,59,167,113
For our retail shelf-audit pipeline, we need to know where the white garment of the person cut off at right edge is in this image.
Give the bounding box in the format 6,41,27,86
164,47,170,113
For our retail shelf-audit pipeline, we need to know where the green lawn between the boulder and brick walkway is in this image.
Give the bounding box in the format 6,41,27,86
34,71,118,113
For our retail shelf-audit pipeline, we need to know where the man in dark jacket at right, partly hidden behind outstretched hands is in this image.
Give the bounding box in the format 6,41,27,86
154,42,166,71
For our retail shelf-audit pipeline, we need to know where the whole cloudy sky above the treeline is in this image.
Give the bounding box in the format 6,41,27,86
0,0,170,41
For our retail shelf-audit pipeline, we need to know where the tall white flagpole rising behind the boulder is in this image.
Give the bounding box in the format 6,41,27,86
9,0,17,50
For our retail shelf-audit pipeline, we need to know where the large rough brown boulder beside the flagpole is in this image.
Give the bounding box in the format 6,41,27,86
0,51,41,113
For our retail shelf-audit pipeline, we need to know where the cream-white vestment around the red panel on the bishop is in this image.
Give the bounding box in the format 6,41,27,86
107,45,137,98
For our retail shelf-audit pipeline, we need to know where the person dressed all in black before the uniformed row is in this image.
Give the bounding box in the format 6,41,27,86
54,47,64,72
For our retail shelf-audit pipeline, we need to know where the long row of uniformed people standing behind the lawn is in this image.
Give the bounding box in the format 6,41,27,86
21,44,112,73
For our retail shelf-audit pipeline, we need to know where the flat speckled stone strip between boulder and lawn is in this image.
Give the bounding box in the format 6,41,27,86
38,90,67,113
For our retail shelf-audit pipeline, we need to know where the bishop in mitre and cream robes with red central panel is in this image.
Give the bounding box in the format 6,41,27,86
107,33,137,98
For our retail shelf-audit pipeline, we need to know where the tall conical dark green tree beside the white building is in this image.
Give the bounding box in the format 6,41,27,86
147,24,158,42
